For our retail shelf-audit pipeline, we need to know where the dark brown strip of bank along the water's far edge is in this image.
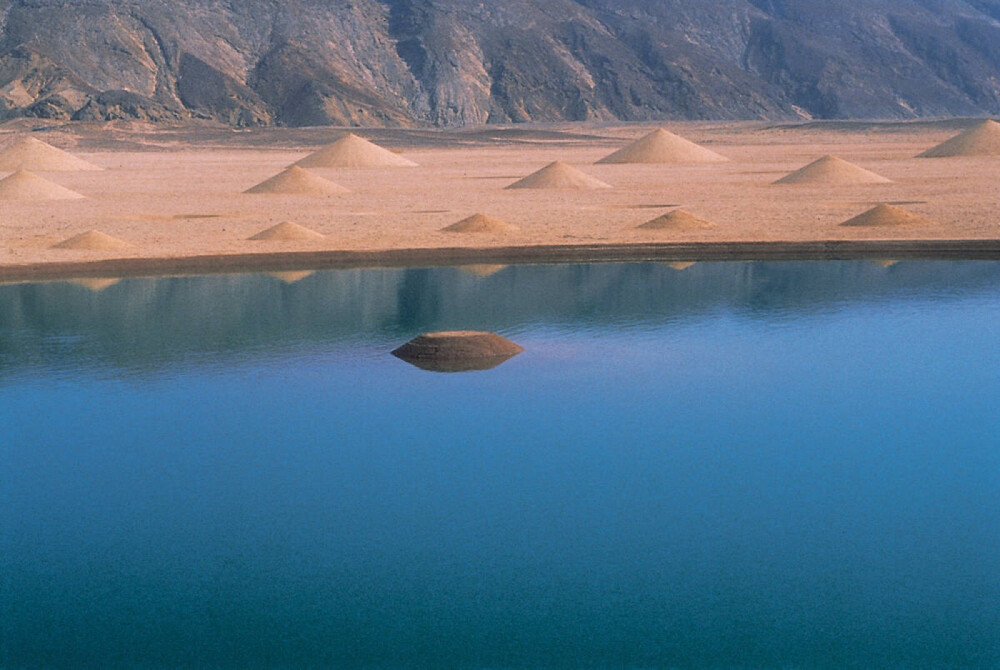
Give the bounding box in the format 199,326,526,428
0,238,1000,283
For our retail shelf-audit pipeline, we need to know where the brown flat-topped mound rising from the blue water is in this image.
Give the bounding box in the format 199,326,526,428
392,330,524,372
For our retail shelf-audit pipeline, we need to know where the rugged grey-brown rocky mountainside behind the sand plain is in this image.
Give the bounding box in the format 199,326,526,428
0,0,1000,126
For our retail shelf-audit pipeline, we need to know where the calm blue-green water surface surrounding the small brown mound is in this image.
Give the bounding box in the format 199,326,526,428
0,261,1000,669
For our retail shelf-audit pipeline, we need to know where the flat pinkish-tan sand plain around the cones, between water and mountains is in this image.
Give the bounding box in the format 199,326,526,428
0,120,1000,281
